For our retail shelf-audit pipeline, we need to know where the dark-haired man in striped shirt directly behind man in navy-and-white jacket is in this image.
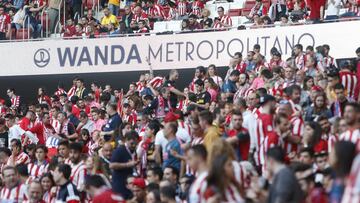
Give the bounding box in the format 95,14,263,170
70,142,86,192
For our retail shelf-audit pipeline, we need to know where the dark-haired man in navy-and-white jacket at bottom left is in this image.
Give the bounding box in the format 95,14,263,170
54,164,80,203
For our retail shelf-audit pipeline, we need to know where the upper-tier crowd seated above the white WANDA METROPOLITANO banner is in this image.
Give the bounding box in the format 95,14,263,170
0,0,360,40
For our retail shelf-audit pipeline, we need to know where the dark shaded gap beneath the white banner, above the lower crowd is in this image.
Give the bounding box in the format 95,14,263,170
0,67,227,103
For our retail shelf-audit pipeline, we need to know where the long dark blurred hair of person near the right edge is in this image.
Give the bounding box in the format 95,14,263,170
333,141,356,177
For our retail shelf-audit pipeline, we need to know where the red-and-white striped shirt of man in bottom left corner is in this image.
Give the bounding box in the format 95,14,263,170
0,184,28,203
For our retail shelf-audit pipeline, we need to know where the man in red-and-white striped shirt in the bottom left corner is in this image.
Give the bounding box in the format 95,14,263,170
0,166,27,202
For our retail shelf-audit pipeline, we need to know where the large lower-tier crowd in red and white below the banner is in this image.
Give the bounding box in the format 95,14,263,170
0,44,360,203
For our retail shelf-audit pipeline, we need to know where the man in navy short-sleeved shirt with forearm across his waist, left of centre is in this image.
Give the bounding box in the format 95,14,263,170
109,131,139,199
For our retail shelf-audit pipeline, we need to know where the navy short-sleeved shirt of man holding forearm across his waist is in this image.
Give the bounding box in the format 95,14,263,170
110,145,133,199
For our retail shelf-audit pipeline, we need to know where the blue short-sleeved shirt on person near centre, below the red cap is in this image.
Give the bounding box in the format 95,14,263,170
163,139,182,170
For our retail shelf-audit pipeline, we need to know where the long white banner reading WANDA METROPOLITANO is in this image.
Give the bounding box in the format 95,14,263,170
0,21,360,76
